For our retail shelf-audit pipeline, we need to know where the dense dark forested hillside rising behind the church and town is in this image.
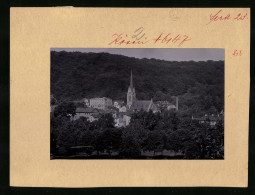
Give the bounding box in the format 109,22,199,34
51,51,224,116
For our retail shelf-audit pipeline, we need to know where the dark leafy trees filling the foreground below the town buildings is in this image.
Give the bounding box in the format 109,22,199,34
51,104,224,159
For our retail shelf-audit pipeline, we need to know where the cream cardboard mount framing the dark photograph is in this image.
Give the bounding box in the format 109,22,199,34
10,7,250,187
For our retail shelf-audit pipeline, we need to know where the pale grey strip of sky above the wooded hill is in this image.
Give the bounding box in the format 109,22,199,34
51,48,225,61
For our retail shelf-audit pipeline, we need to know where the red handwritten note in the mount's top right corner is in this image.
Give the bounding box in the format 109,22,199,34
206,9,248,25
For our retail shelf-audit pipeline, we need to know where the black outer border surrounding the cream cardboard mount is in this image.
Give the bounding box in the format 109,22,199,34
0,0,255,195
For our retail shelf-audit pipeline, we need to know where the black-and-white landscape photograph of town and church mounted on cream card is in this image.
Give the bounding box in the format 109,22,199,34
50,48,225,160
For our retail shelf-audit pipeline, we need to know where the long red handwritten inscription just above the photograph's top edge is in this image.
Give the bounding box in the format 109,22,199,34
108,33,191,47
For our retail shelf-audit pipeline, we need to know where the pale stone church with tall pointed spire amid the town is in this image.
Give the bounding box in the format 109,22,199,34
127,70,159,112
